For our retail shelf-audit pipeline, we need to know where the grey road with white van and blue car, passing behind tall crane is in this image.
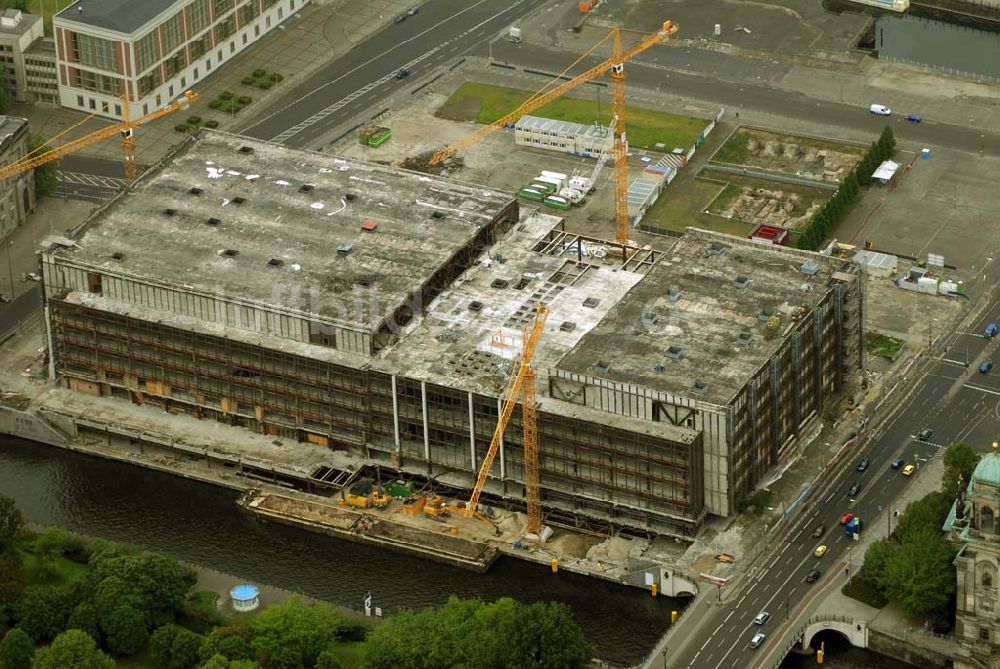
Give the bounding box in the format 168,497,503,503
493,41,1000,155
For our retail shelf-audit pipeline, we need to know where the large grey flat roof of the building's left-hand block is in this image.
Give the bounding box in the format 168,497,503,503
50,131,514,330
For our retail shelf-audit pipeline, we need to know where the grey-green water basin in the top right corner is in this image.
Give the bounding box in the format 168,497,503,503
875,15,1000,79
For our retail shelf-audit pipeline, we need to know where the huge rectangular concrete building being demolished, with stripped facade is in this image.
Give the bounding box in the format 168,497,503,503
42,133,862,537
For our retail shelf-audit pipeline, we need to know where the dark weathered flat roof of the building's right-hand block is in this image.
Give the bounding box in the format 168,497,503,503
558,230,850,405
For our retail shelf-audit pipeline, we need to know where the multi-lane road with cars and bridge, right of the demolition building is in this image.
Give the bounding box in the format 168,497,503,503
668,261,1000,669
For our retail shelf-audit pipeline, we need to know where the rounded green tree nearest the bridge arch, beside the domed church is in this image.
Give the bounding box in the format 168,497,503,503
884,528,957,615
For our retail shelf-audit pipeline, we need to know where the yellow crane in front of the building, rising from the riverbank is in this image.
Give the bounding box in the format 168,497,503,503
465,304,549,534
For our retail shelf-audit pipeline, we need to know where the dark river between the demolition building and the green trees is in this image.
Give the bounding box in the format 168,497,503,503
0,436,683,664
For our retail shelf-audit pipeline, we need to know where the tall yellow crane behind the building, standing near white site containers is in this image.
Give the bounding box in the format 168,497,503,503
429,21,677,244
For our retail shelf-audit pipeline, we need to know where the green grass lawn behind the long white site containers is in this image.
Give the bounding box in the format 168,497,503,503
437,81,708,151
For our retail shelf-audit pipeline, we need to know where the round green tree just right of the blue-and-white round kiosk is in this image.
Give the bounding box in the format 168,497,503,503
250,597,347,669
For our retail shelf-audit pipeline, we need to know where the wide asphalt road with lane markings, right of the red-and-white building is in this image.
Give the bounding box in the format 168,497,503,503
241,0,545,147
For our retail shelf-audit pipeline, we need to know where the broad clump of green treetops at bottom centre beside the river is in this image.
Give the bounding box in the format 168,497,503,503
364,597,592,669
